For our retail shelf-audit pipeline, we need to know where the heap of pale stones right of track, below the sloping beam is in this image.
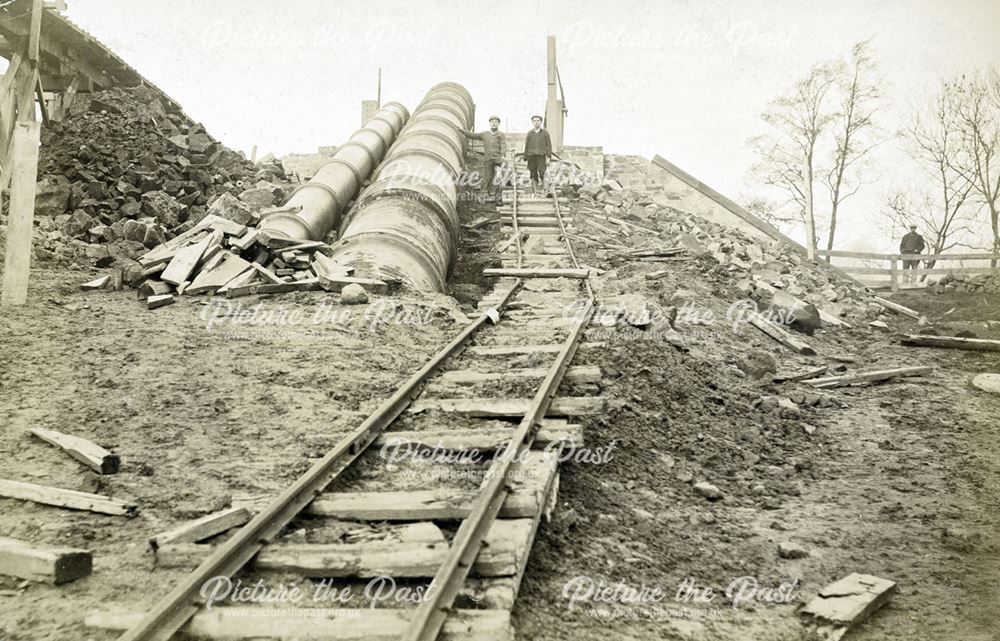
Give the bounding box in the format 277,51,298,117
579,180,880,324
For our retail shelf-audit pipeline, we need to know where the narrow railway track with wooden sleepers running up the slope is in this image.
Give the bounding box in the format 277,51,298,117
88,156,603,641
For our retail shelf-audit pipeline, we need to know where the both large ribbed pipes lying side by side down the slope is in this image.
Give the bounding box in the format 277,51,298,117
260,82,475,292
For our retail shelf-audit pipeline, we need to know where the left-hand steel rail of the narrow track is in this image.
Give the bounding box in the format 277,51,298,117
119,281,521,641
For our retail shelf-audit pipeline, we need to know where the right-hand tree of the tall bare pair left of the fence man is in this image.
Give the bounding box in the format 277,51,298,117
825,40,881,255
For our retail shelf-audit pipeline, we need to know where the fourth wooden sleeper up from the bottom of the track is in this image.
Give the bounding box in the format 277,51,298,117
373,419,583,452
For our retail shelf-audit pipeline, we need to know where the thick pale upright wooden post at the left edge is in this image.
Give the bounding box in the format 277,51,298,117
0,121,41,305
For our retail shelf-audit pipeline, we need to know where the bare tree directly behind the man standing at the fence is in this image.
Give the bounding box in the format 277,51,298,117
884,84,975,267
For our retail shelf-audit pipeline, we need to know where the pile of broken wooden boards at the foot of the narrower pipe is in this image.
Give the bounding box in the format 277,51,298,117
81,215,388,309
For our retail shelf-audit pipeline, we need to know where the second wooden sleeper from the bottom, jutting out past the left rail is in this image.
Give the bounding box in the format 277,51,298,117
156,519,532,579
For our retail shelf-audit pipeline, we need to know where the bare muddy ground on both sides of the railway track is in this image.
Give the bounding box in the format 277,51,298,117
0,202,1000,641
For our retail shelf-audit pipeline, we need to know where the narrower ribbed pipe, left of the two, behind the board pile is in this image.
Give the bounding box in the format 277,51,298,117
259,102,410,240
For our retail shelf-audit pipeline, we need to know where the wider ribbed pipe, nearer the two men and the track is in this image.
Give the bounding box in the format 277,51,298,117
333,82,474,292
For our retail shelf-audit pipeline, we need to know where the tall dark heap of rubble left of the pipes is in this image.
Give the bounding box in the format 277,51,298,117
10,87,287,266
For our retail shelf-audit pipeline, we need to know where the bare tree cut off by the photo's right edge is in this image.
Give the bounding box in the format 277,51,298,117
951,70,1000,267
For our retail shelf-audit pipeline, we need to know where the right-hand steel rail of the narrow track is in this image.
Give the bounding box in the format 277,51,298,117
402,174,595,641
